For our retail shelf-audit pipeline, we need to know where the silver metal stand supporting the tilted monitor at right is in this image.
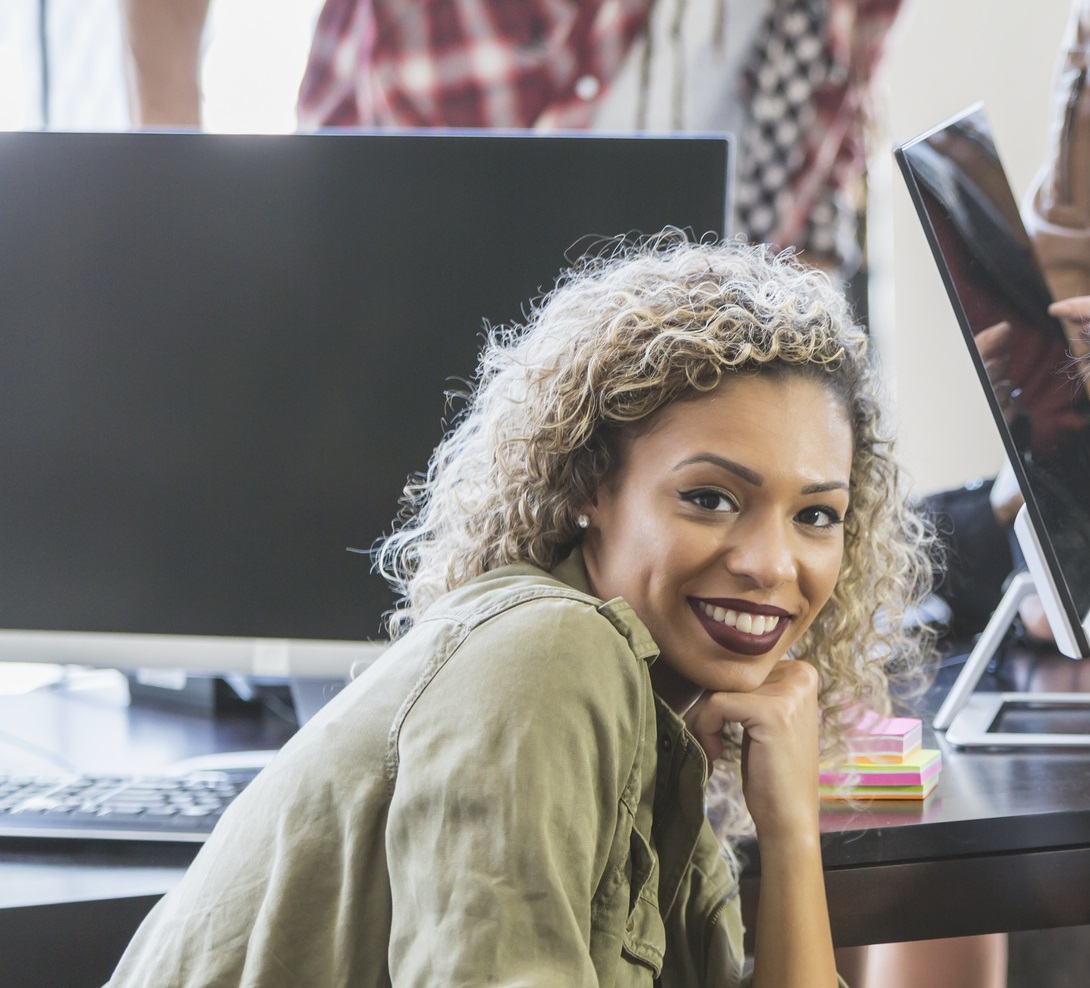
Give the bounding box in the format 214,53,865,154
932,573,1090,748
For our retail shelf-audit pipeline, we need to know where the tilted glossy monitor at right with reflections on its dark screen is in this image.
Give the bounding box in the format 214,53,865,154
896,107,1090,656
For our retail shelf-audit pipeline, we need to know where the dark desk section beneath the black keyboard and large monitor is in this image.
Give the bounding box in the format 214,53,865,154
0,670,295,988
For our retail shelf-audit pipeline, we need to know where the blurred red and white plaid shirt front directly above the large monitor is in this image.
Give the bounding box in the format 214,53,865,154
299,0,652,130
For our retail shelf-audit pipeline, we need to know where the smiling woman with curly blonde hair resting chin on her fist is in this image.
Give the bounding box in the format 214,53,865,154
104,233,930,988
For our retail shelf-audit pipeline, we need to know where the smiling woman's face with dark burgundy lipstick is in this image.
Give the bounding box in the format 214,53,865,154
583,373,852,710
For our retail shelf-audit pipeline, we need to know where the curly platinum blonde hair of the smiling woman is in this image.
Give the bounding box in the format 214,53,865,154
376,232,931,820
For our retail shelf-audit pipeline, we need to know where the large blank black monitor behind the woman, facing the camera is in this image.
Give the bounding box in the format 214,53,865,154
0,125,729,675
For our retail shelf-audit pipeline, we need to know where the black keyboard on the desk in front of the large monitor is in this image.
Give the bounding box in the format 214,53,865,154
0,768,258,842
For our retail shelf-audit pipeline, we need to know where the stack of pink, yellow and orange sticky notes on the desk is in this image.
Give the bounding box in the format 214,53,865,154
819,712,943,799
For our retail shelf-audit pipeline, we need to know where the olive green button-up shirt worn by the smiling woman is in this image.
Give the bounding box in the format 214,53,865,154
109,552,742,988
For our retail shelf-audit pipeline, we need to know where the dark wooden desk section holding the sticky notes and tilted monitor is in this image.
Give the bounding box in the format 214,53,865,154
742,649,1090,947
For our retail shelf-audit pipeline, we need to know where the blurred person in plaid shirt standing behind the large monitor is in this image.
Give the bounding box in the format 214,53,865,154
123,0,901,277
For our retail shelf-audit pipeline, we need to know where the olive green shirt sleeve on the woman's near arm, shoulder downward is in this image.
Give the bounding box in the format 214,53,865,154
387,600,650,988
